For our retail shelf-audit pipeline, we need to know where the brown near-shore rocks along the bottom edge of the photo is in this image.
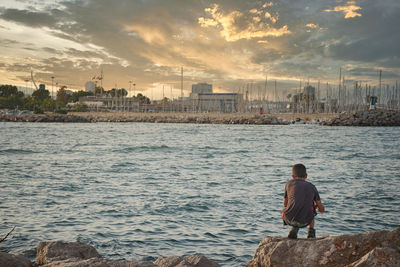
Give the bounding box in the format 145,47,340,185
0,228,400,267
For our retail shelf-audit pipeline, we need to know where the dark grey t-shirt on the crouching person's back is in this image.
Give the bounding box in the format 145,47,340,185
283,179,320,224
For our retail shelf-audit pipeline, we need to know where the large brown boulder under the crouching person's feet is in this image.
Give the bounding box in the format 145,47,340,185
246,228,400,267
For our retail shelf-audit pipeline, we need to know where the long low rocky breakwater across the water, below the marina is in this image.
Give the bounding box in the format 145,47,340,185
0,110,400,126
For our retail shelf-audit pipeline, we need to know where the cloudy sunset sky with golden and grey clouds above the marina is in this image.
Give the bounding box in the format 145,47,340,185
0,0,400,98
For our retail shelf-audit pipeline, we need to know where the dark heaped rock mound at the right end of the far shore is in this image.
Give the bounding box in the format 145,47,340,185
320,110,400,126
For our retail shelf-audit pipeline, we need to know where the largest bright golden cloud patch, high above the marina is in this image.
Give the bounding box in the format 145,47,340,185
198,4,292,42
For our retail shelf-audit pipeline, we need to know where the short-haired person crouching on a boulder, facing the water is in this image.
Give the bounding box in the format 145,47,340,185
281,164,325,239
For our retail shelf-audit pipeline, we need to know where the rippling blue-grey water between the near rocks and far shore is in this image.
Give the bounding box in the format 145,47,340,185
0,123,400,266
